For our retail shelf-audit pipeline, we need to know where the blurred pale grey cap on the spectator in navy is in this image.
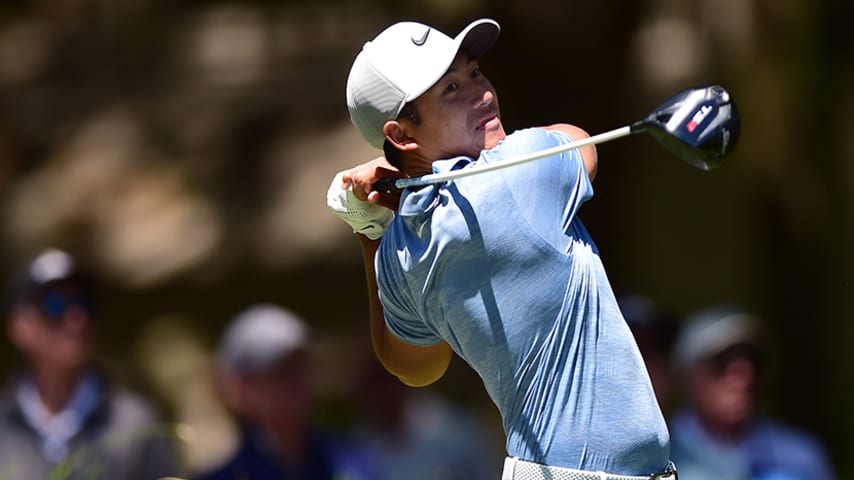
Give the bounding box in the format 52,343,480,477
217,304,309,374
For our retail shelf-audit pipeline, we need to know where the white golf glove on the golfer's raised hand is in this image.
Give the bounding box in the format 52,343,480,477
326,171,394,240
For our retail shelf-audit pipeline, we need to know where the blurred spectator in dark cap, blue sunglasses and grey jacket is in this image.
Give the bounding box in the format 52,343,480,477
0,249,181,480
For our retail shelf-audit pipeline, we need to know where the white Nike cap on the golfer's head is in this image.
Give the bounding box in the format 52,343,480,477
347,19,500,148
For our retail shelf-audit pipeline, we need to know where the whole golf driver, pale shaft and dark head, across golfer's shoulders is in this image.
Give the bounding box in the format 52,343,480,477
374,85,741,192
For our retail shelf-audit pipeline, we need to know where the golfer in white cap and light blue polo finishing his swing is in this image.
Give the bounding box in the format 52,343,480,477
327,19,675,480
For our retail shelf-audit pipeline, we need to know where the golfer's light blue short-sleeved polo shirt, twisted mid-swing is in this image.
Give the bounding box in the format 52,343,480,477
375,129,669,475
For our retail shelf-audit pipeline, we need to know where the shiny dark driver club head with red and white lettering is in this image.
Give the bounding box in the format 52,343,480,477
632,85,741,170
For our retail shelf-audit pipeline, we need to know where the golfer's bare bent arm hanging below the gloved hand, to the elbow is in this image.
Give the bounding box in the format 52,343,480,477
356,235,453,387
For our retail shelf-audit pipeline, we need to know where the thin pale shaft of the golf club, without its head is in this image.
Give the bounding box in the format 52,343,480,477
386,126,634,190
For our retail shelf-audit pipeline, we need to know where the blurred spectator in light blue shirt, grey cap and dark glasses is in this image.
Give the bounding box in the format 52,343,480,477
671,306,834,480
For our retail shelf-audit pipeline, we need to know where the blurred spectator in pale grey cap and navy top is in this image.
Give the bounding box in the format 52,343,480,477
198,304,381,480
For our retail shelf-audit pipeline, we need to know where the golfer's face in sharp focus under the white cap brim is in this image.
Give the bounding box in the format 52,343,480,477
414,53,505,159
